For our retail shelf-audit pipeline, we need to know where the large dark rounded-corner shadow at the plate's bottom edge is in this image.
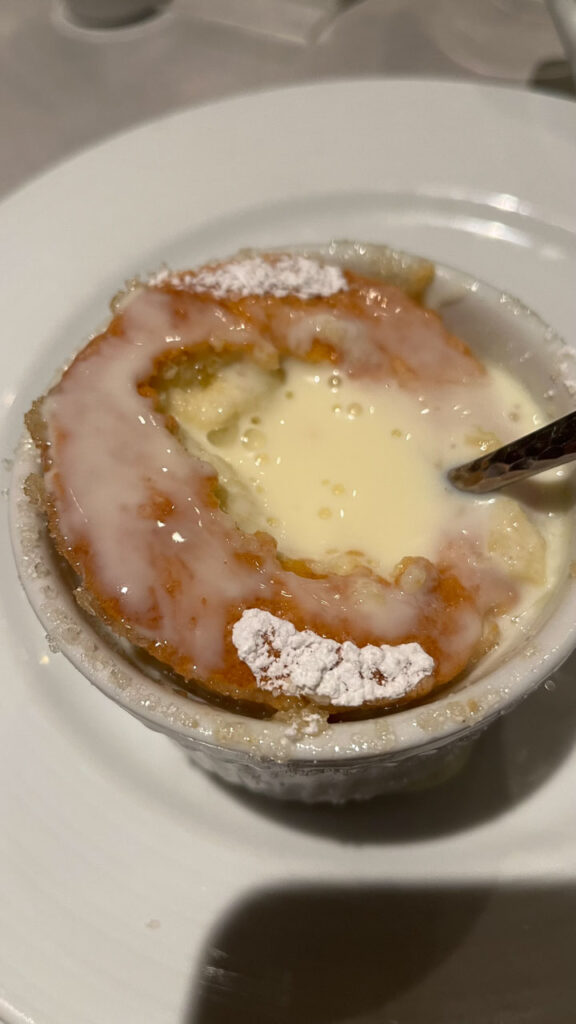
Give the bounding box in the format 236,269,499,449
181,886,576,1024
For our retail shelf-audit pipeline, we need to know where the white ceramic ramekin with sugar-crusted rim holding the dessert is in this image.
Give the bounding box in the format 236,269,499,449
11,251,576,802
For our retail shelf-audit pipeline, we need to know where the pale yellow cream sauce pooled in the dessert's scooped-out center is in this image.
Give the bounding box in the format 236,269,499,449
166,359,556,598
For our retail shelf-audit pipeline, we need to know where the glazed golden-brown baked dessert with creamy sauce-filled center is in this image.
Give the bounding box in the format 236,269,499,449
27,245,560,714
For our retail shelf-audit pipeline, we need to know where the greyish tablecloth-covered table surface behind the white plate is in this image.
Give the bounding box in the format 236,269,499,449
0,0,572,197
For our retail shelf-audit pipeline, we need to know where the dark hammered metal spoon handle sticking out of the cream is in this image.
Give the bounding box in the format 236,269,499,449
448,413,576,494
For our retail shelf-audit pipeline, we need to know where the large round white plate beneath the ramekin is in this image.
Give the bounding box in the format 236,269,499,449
0,81,576,1024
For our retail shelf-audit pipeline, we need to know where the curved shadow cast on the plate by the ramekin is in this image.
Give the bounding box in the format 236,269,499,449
203,655,576,843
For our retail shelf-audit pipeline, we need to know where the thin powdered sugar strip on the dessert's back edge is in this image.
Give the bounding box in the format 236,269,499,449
150,255,347,299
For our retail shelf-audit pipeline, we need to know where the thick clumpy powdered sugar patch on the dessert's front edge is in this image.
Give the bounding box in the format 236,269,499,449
233,608,435,708
